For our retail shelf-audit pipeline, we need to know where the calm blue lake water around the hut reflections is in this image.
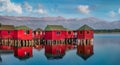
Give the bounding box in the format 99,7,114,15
0,34,120,65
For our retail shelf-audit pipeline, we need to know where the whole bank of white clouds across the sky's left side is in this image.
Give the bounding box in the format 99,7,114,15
0,0,47,14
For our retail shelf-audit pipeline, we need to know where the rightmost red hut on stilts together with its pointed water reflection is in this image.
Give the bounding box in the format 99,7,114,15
77,25,93,60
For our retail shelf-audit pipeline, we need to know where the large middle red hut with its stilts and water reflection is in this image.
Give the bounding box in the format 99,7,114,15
44,25,66,59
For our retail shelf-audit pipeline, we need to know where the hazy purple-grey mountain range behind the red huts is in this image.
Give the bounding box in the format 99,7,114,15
0,16,120,29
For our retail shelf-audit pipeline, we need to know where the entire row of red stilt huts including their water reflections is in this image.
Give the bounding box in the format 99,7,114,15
0,25,94,60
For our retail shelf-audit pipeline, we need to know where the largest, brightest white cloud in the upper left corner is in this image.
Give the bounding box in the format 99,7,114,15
0,0,22,14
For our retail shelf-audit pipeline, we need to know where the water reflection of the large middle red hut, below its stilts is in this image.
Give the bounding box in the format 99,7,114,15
45,44,66,59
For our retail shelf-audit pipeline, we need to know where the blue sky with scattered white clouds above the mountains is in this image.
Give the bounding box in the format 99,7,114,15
0,0,120,21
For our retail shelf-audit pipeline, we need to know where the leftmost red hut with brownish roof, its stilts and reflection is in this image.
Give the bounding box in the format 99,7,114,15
0,25,14,50
